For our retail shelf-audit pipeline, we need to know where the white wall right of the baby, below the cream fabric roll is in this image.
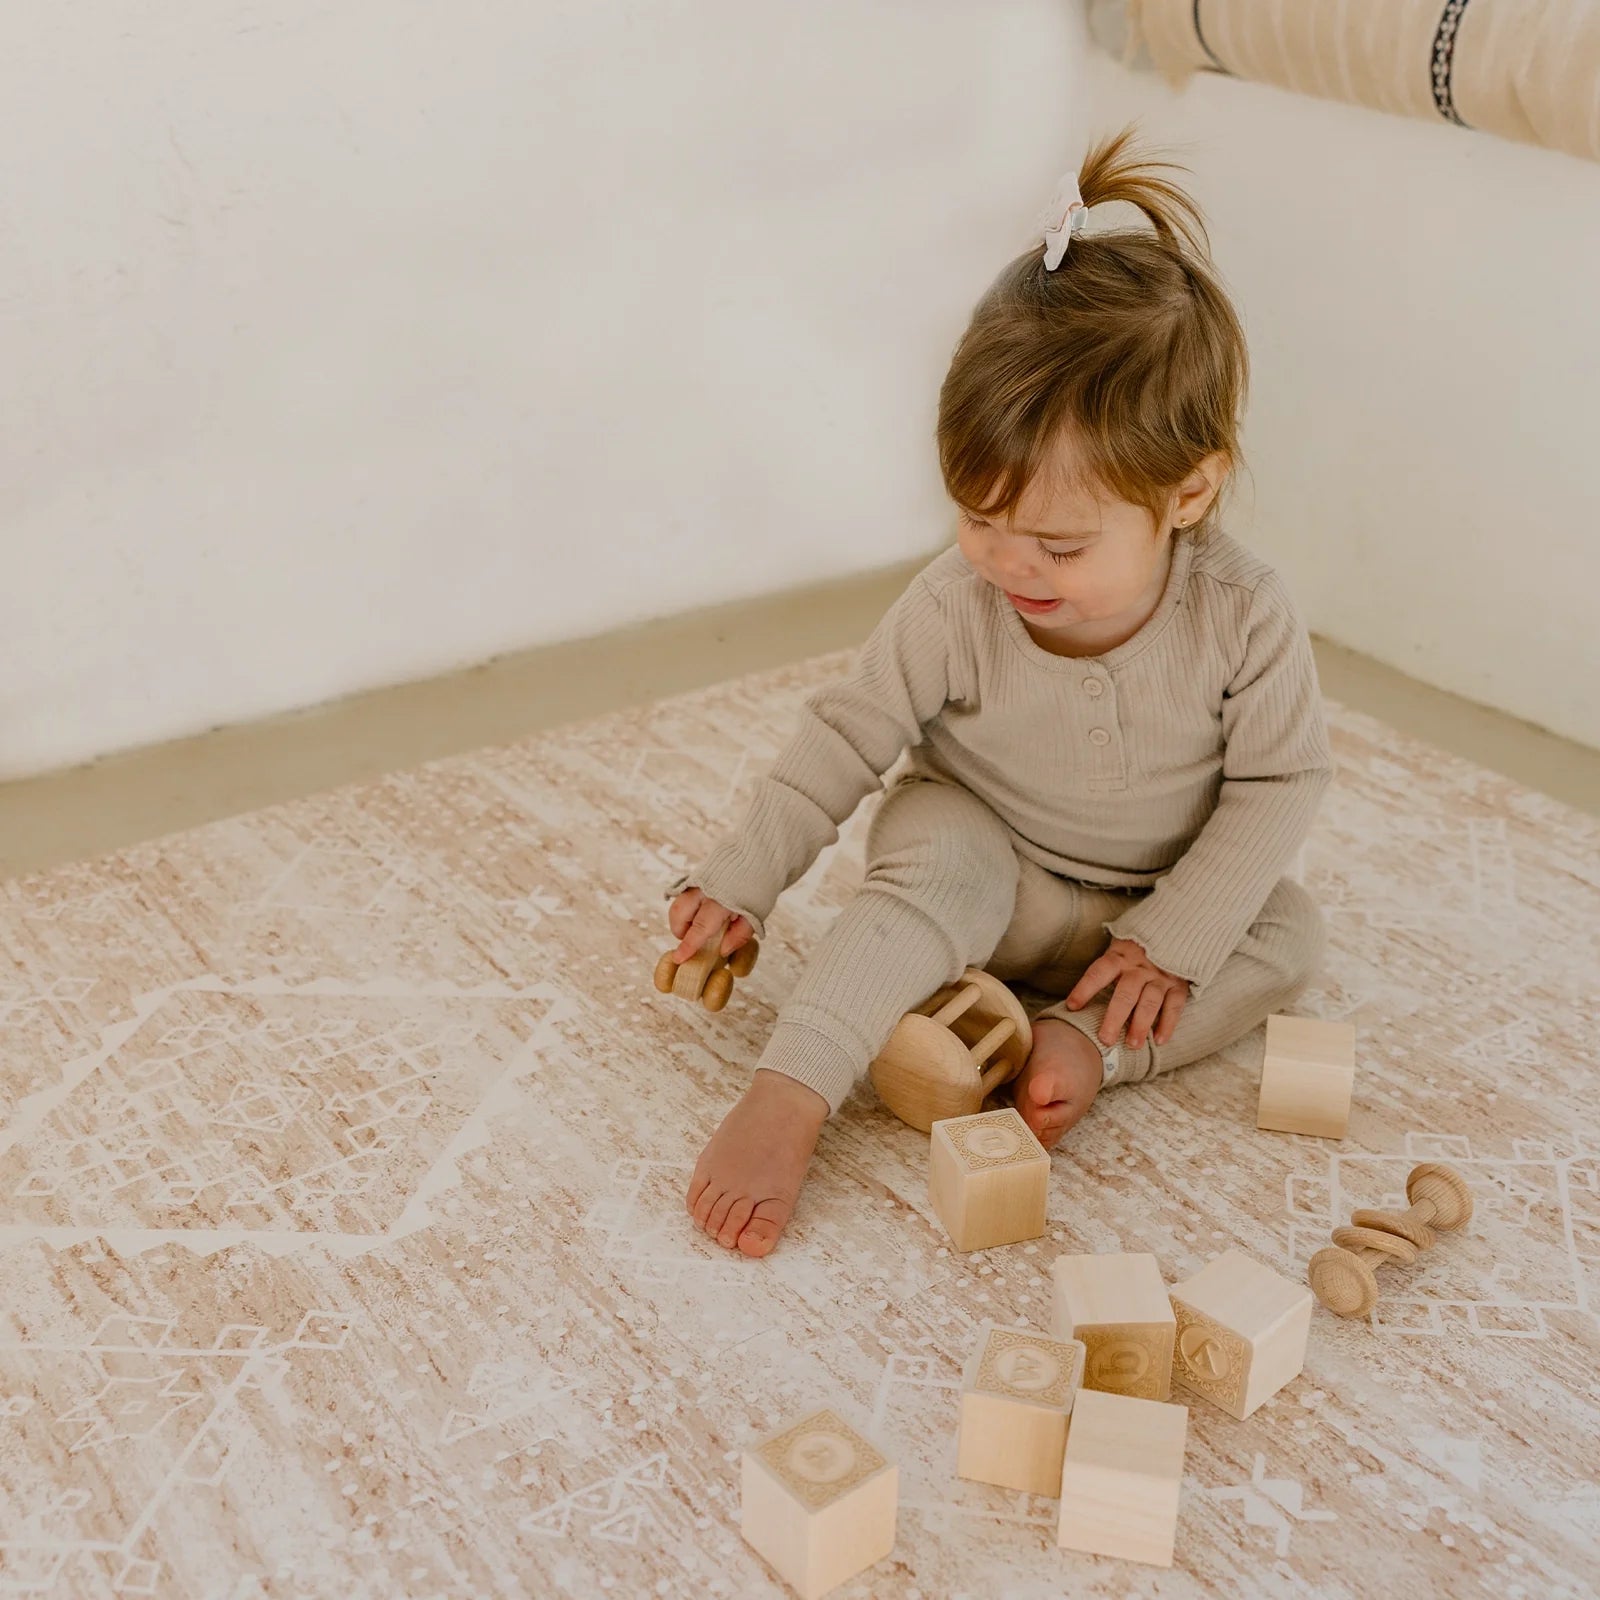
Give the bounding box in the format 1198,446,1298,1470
1090,51,1600,744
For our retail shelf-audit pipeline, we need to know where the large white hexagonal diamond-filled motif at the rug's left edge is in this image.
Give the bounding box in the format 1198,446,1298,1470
0,978,579,1256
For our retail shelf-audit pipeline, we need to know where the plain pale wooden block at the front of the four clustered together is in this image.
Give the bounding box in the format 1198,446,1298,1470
1056,1389,1189,1566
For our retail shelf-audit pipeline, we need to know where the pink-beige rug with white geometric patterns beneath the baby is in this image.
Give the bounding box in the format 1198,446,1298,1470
0,656,1600,1600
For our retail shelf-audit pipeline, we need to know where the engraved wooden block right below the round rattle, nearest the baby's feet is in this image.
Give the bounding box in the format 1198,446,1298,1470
928,1106,1050,1250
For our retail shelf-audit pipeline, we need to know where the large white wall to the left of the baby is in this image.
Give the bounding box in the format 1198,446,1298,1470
0,0,1082,778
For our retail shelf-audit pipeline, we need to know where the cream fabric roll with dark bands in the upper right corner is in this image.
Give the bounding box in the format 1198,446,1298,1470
1128,0,1600,160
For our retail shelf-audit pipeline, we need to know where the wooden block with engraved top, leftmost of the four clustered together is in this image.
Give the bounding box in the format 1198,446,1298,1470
955,1322,1083,1494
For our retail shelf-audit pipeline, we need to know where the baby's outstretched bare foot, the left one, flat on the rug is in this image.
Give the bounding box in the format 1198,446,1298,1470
685,1068,825,1256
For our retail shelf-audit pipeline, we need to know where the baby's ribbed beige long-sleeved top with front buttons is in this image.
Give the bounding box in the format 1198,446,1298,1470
667,534,1333,989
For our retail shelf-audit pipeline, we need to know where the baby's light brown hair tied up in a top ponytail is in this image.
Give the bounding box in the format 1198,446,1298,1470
938,128,1250,531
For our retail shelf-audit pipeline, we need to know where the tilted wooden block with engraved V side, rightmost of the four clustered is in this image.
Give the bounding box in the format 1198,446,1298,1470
1171,1250,1312,1421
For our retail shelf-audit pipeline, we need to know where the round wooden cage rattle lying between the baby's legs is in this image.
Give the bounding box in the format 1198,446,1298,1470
870,966,1034,1133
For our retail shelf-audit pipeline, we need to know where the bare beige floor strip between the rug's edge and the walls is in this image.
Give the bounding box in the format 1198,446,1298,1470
0,562,1600,878
